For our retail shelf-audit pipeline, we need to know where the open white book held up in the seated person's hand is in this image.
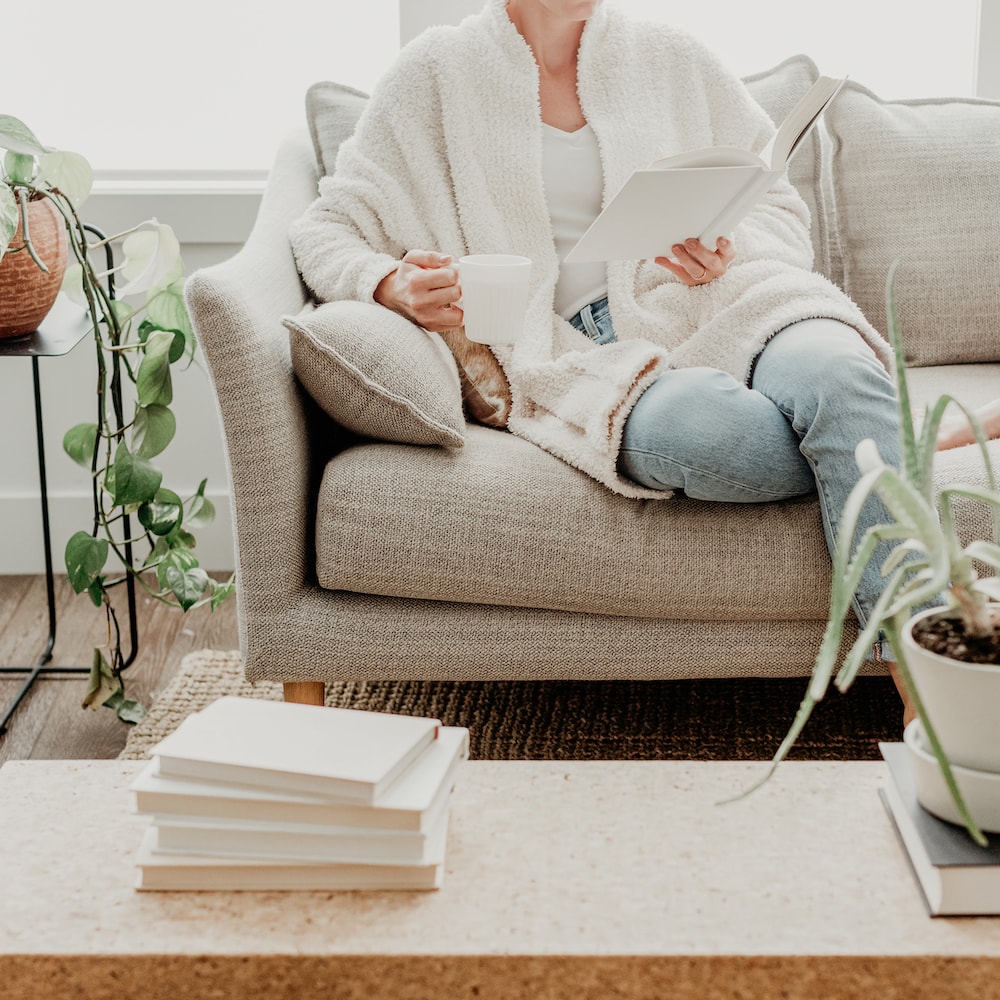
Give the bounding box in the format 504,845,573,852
565,76,845,264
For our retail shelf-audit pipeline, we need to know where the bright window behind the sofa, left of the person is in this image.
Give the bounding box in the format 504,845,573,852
8,0,398,176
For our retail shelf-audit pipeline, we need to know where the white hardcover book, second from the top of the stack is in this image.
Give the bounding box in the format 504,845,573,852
129,726,469,832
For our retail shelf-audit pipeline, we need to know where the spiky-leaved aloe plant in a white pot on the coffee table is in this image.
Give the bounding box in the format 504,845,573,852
754,262,1000,844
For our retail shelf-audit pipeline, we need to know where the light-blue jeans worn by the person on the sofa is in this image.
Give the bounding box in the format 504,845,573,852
571,300,900,632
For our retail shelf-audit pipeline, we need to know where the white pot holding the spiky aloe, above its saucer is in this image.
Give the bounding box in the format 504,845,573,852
902,604,1000,773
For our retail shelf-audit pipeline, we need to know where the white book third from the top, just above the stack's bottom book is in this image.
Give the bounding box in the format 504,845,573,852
153,799,448,865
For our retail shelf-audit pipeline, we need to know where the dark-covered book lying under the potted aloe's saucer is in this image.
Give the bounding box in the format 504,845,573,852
879,743,1000,917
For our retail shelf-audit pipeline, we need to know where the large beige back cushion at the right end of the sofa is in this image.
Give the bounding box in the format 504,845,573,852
826,82,1000,365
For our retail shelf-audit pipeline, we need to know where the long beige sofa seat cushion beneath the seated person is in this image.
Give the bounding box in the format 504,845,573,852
316,425,830,621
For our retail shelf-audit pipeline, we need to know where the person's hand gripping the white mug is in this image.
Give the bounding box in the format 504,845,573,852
374,250,465,333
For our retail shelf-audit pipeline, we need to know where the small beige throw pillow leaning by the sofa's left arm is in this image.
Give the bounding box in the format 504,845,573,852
282,302,466,448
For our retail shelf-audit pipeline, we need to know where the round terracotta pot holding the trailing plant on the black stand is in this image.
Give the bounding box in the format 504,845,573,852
0,198,67,337
